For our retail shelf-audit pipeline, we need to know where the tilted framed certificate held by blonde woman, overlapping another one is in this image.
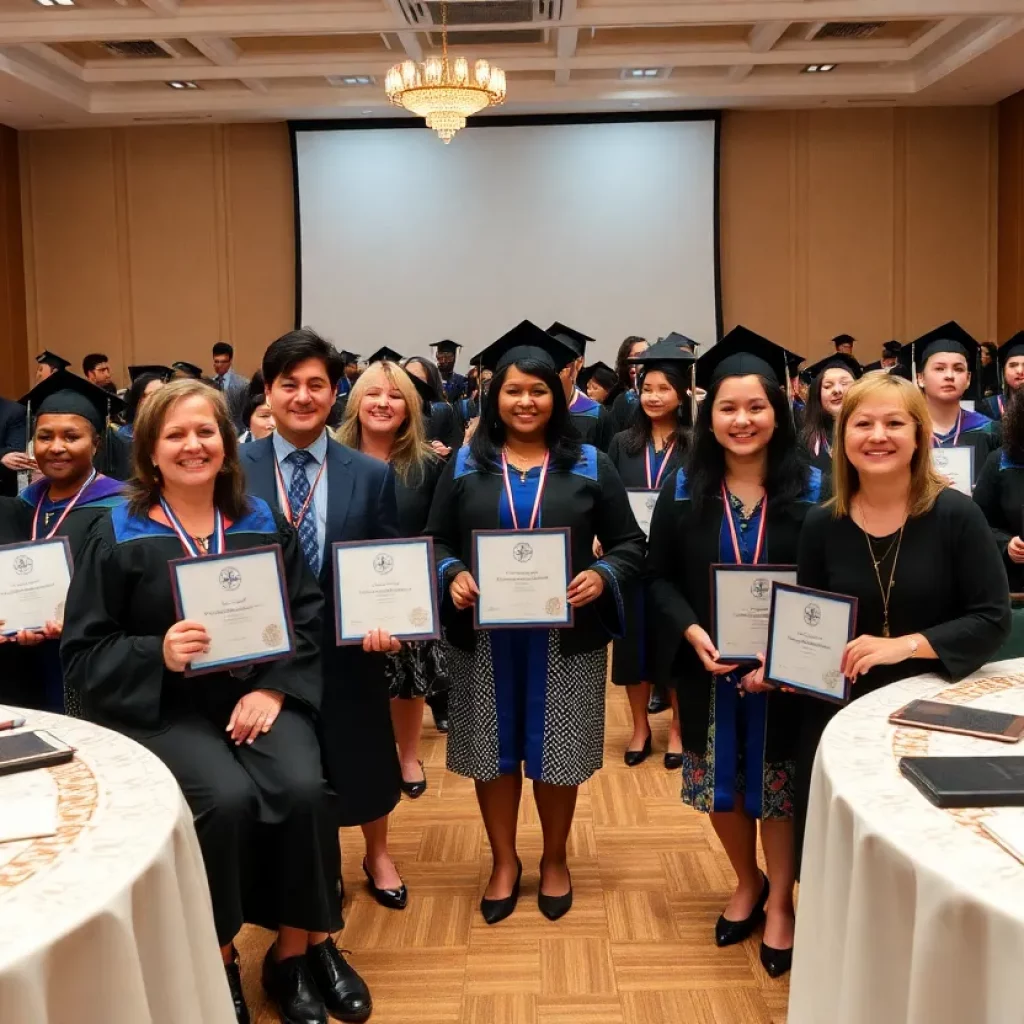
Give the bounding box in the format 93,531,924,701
765,584,857,703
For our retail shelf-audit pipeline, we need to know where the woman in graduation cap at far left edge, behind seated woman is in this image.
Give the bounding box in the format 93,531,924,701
0,370,122,716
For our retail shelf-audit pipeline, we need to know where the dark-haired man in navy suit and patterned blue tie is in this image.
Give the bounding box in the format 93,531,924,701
241,330,404,1021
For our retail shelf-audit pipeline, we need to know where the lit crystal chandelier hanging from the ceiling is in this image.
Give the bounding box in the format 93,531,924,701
384,2,505,145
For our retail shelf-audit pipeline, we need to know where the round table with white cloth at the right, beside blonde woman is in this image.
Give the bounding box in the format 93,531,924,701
788,658,1024,1024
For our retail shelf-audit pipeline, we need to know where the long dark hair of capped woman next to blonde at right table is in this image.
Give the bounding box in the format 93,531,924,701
686,377,809,514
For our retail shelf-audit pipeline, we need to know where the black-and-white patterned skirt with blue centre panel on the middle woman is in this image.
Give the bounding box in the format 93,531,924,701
444,629,607,785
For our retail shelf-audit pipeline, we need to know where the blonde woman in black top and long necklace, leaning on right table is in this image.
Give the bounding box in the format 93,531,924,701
797,374,1010,854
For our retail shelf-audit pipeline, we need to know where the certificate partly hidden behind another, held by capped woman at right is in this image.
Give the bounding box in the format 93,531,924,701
711,564,797,663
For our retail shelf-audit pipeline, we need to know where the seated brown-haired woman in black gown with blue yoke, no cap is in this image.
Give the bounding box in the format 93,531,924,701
61,380,352,1024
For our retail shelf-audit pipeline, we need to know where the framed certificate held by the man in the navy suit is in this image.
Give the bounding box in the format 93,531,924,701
332,537,440,646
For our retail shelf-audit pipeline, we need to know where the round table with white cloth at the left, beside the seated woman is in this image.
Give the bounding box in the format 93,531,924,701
0,712,234,1024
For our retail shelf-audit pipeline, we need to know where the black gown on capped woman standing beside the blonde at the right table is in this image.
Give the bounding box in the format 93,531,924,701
646,469,821,762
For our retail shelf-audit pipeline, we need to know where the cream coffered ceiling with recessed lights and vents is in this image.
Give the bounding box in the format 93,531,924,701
0,0,1024,128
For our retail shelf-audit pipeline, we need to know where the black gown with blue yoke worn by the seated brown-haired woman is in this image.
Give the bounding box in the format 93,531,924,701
60,499,340,944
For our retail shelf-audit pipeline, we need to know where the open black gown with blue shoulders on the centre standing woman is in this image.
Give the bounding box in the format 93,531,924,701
426,444,644,657
